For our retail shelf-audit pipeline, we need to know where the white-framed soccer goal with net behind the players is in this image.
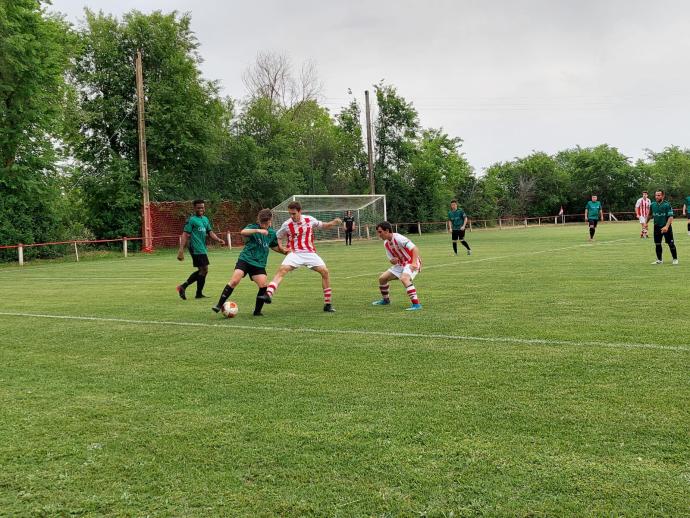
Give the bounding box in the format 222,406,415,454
273,194,386,243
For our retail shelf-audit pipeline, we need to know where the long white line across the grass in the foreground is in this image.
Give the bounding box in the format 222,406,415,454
0,311,690,352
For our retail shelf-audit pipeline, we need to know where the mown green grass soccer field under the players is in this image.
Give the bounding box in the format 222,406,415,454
0,222,690,516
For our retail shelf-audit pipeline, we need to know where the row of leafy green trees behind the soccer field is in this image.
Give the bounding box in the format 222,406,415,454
0,0,690,258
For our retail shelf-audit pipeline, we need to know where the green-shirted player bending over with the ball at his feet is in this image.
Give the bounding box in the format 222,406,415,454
211,209,288,317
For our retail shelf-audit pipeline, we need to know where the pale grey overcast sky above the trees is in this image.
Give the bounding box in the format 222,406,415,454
52,0,690,175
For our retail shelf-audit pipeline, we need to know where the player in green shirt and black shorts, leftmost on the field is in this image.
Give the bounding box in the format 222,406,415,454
177,200,225,300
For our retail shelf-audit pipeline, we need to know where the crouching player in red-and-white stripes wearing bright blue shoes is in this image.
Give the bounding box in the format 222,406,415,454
372,221,422,311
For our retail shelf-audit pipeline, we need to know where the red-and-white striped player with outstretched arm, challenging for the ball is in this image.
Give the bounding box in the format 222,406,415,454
257,201,343,313
